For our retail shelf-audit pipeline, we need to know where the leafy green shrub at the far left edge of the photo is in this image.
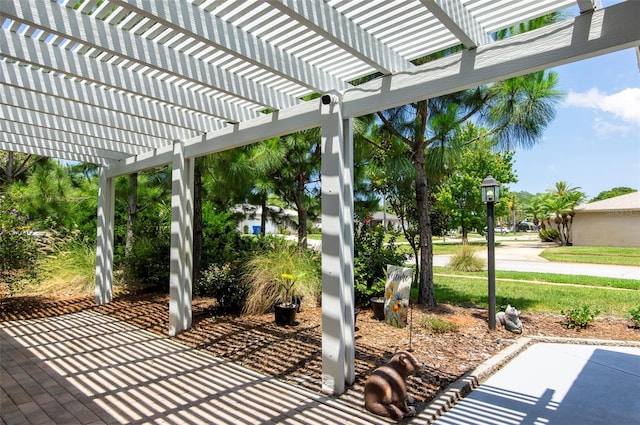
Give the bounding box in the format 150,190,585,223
0,198,38,293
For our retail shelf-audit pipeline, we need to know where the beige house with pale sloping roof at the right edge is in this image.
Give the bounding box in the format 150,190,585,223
571,192,640,248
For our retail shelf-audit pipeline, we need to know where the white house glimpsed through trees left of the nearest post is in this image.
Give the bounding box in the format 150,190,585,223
232,204,298,235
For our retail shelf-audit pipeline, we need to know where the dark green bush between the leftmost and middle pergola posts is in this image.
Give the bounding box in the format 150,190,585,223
120,235,170,292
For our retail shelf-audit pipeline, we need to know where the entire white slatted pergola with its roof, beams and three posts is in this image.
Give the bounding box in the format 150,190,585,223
0,0,640,394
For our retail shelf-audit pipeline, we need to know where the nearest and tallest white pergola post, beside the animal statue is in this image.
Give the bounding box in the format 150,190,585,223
321,96,355,394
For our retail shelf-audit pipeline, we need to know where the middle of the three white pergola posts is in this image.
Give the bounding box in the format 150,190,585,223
169,141,195,336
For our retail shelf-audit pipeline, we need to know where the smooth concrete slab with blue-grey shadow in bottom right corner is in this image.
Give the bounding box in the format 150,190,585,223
424,343,640,425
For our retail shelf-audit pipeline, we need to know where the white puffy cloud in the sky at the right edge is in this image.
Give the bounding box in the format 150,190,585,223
563,87,640,127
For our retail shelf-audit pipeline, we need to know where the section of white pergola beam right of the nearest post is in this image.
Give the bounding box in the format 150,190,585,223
342,2,640,117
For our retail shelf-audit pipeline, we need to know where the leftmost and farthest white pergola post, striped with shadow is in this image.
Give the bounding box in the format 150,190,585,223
96,167,115,305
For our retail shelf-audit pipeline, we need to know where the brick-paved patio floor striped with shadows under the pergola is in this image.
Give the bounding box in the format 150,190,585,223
0,312,387,425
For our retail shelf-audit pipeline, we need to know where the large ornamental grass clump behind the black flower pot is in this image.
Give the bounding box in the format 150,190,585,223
242,237,322,315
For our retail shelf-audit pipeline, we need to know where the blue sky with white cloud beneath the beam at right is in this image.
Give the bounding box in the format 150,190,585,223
508,1,640,199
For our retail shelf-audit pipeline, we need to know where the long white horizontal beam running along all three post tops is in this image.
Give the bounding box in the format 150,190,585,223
109,2,640,179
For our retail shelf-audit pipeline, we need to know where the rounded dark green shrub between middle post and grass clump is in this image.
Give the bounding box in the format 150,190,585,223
193,264,248,314
